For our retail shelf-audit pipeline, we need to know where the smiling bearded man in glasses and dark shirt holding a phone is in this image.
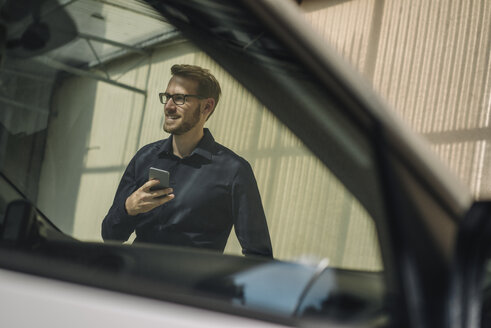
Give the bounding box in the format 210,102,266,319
102,65,272,257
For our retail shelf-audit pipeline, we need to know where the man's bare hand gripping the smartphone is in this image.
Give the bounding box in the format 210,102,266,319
125,180,174,216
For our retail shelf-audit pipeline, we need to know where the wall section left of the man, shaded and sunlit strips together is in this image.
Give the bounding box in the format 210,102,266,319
39,70,144,240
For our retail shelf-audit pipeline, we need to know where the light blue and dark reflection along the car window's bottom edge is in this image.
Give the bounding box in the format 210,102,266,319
196,261,384,321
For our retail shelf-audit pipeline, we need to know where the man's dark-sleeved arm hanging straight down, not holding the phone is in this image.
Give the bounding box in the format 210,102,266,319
232,162,273,257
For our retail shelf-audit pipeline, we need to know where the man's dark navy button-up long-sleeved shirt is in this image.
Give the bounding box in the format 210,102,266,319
102,129,272,256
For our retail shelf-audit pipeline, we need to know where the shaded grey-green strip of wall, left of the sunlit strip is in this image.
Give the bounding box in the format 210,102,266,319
38,79,101,233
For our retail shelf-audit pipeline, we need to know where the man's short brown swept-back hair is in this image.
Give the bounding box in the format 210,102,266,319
170,64,222,117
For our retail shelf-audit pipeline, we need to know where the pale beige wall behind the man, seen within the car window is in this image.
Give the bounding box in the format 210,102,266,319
40,43,381,270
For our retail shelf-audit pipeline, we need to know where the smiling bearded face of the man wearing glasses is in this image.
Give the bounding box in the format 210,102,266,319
164,76,204,135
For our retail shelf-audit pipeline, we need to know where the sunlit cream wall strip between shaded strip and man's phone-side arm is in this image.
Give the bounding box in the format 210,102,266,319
69,81,145,240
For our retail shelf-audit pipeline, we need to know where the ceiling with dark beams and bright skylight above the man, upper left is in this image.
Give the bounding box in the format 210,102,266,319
0,0,180,134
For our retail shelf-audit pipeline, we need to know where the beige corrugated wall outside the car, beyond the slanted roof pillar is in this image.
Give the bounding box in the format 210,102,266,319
302,0,491,199
